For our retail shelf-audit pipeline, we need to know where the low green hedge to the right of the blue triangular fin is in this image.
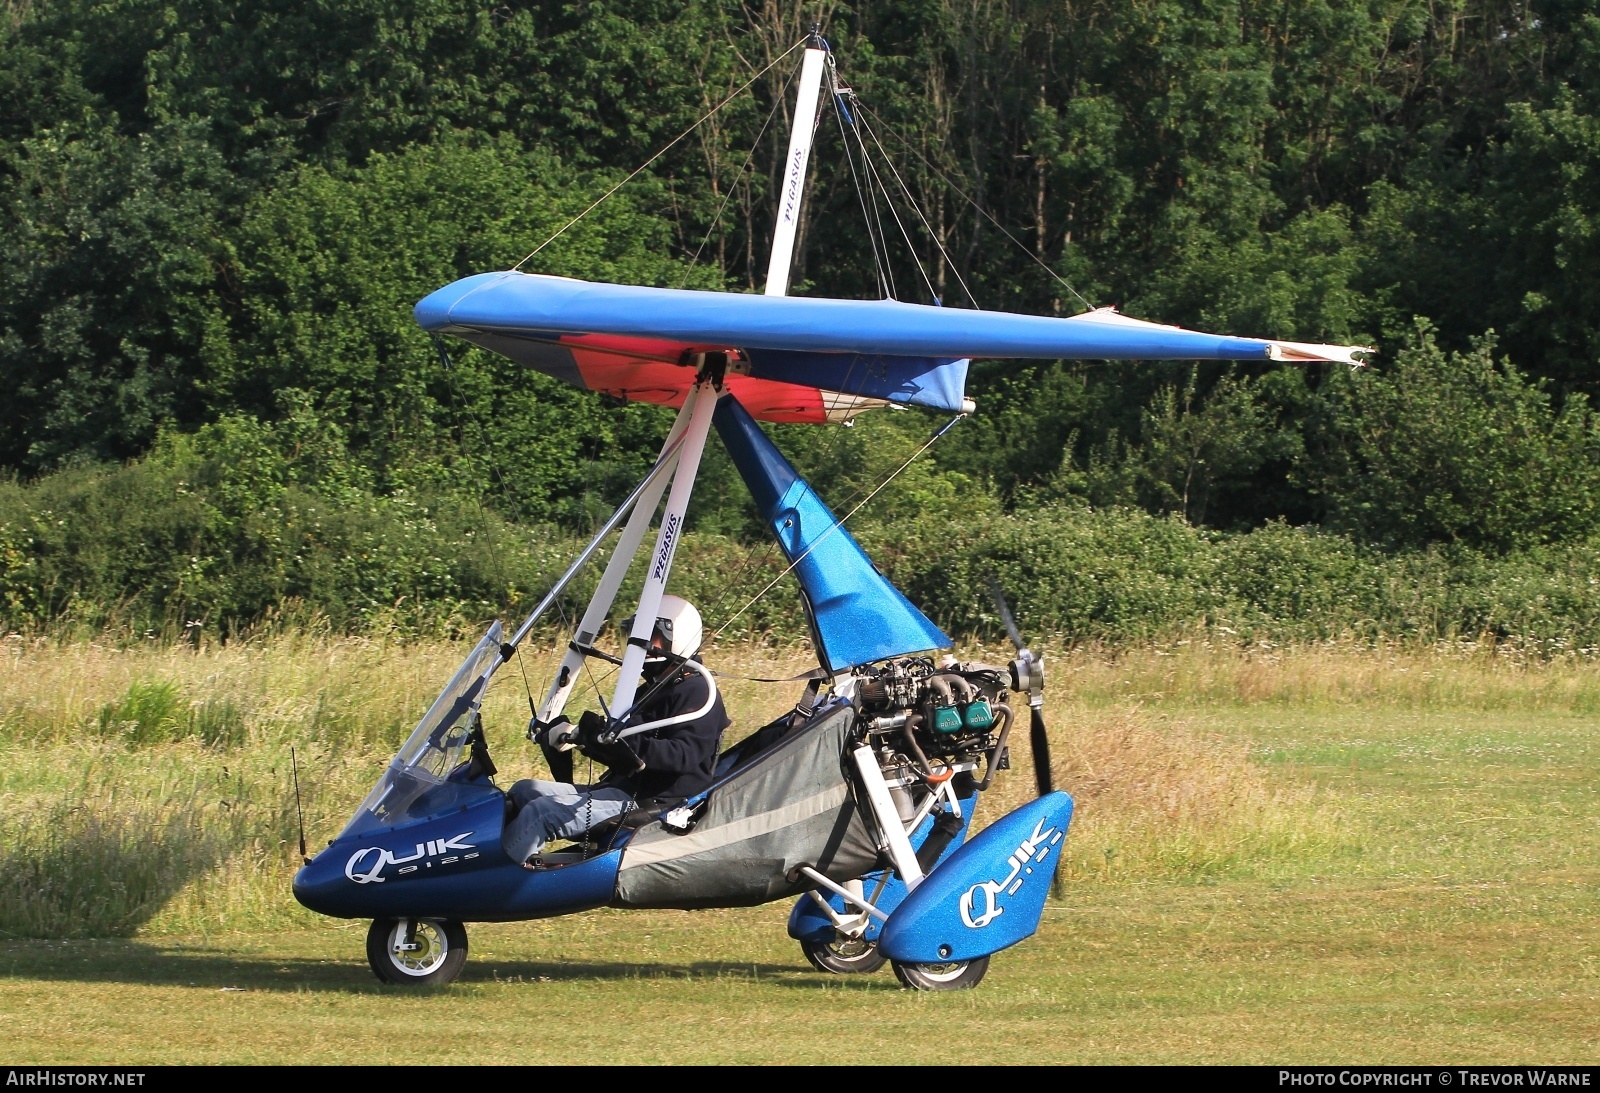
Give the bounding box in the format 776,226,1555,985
893,507,1600,651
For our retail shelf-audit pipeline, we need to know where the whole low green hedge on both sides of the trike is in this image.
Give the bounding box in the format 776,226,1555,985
9,418,1600,652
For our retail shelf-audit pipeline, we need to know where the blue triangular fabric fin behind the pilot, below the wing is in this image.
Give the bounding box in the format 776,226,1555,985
712,395,950,672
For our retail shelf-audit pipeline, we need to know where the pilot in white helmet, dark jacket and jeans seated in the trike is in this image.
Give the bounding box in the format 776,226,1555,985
501,595,730,864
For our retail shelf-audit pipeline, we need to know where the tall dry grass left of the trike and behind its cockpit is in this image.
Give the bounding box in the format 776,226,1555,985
0,634,838,936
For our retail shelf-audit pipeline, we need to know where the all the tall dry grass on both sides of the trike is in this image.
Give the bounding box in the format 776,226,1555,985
21,634,1600,936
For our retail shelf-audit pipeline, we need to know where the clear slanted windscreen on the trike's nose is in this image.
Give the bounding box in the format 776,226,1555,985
341,621,504,837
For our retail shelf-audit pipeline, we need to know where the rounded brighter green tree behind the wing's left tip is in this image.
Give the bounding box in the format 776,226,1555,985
216,138,715,520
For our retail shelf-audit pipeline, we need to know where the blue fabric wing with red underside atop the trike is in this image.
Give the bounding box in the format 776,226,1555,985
416,272,1360,422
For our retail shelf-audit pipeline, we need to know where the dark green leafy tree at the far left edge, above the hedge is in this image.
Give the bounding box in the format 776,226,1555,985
0,120,234,470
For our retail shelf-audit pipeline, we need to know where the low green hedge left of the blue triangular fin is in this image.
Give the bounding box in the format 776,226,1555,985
0,416,805,646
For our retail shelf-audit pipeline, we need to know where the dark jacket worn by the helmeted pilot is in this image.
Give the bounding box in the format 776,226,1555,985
600,669,733,803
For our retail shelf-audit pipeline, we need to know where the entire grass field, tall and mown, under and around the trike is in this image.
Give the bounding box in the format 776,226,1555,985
0,639,1600,1063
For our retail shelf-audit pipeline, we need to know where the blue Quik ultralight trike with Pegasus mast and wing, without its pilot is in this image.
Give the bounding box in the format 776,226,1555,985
294,34,1355,991
